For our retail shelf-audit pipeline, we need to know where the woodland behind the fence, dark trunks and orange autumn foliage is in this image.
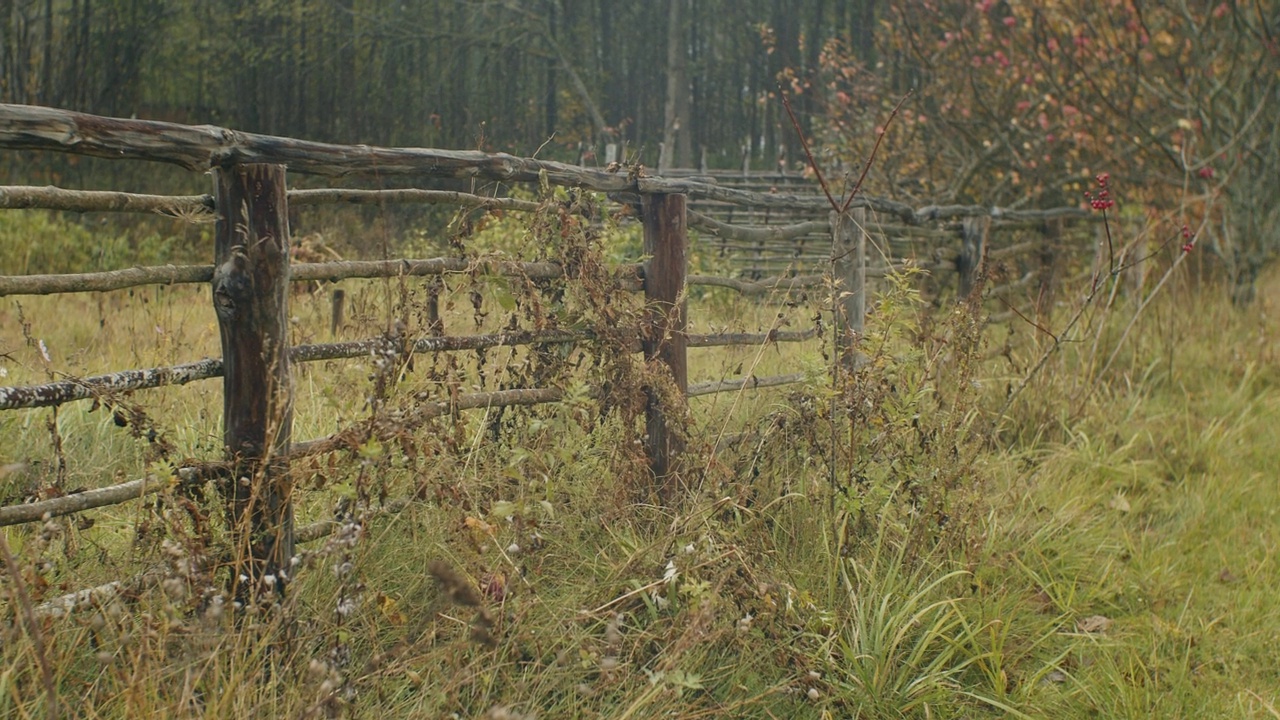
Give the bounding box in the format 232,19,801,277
0,0,1280,294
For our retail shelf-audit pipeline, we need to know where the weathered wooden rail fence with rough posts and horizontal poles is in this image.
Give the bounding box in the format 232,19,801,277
0,105,1085,605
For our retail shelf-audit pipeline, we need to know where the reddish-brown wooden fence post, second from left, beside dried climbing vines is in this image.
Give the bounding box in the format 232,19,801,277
640,189,689,502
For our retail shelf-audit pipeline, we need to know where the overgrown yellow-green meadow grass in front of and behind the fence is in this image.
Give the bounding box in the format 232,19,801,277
0,204,1280,719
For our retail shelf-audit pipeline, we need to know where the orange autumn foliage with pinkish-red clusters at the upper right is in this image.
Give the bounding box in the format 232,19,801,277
791,0,1280,301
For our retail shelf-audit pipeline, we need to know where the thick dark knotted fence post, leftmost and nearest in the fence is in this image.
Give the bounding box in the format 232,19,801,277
212,164,294,603
